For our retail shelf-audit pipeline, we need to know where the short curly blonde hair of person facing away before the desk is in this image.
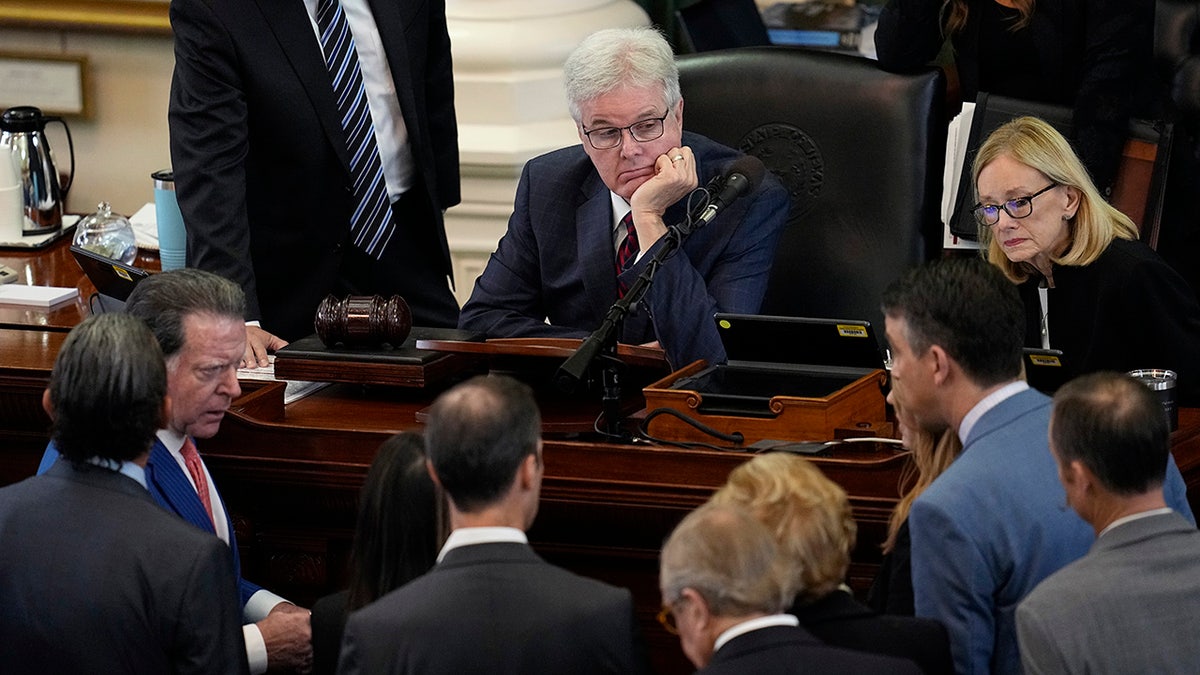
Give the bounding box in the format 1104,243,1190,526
709,453,858,602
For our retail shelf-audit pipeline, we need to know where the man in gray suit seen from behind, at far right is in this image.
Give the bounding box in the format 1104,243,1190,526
1016,372,1200,674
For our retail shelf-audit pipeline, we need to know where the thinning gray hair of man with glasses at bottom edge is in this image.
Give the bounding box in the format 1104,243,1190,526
659,503,794,616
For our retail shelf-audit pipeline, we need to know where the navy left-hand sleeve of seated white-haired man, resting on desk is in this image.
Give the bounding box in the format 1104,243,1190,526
458,162,588,338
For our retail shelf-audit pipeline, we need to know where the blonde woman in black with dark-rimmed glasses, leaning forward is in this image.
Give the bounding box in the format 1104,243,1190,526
974,117,1200,405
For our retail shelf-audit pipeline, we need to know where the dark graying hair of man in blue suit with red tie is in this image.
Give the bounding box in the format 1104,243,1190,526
125,268,246,359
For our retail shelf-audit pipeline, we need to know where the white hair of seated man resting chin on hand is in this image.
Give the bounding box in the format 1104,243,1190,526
563,26,683,123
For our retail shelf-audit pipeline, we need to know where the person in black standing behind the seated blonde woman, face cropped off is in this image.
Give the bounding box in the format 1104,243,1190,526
875,0,1156,194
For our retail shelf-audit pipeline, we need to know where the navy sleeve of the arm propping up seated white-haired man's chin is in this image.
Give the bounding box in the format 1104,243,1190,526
622,177,787,368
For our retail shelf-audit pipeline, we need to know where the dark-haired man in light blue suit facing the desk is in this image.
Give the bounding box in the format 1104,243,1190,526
883,259,1194,674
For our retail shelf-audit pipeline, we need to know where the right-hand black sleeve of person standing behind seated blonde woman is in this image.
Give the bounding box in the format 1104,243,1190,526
1074,0,1154,192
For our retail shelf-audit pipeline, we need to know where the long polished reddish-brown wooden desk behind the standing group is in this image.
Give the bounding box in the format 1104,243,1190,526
7,234,1200,673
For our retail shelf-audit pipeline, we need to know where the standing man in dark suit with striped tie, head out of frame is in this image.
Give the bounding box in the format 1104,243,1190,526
169,0,460,365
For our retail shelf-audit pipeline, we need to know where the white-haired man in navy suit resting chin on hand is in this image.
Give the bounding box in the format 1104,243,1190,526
460,28,787,366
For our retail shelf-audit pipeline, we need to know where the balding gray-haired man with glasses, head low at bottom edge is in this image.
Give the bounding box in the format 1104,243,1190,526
659,503,920,675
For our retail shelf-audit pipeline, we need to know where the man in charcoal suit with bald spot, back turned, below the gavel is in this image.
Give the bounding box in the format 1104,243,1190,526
338,377,647,675
